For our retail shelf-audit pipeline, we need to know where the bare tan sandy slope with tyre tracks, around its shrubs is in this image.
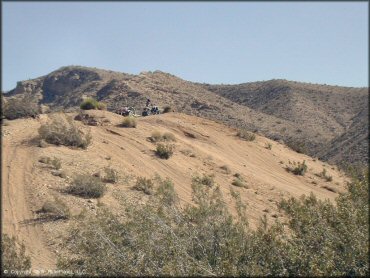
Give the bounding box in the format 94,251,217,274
2,111,346,268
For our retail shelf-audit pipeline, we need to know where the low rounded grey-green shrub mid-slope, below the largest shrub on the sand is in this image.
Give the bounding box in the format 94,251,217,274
65,174,106,198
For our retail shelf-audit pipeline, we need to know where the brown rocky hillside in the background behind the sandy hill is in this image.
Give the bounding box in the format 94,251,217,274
5,66,368,166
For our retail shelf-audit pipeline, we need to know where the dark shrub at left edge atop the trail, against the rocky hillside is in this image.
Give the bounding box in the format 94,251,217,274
3,97,40,120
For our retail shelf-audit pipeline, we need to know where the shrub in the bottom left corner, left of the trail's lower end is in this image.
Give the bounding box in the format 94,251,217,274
1,234,31,276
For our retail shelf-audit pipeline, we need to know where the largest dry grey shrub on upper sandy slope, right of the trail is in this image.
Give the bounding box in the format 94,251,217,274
38,114,92,149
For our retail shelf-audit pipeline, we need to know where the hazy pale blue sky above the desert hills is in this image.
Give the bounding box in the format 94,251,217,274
2,2,369,90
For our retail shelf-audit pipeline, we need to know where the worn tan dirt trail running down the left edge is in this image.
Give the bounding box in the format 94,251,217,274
2,120,55,269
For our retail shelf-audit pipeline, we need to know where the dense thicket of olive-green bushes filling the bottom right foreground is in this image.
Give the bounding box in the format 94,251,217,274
58,169,369,277
